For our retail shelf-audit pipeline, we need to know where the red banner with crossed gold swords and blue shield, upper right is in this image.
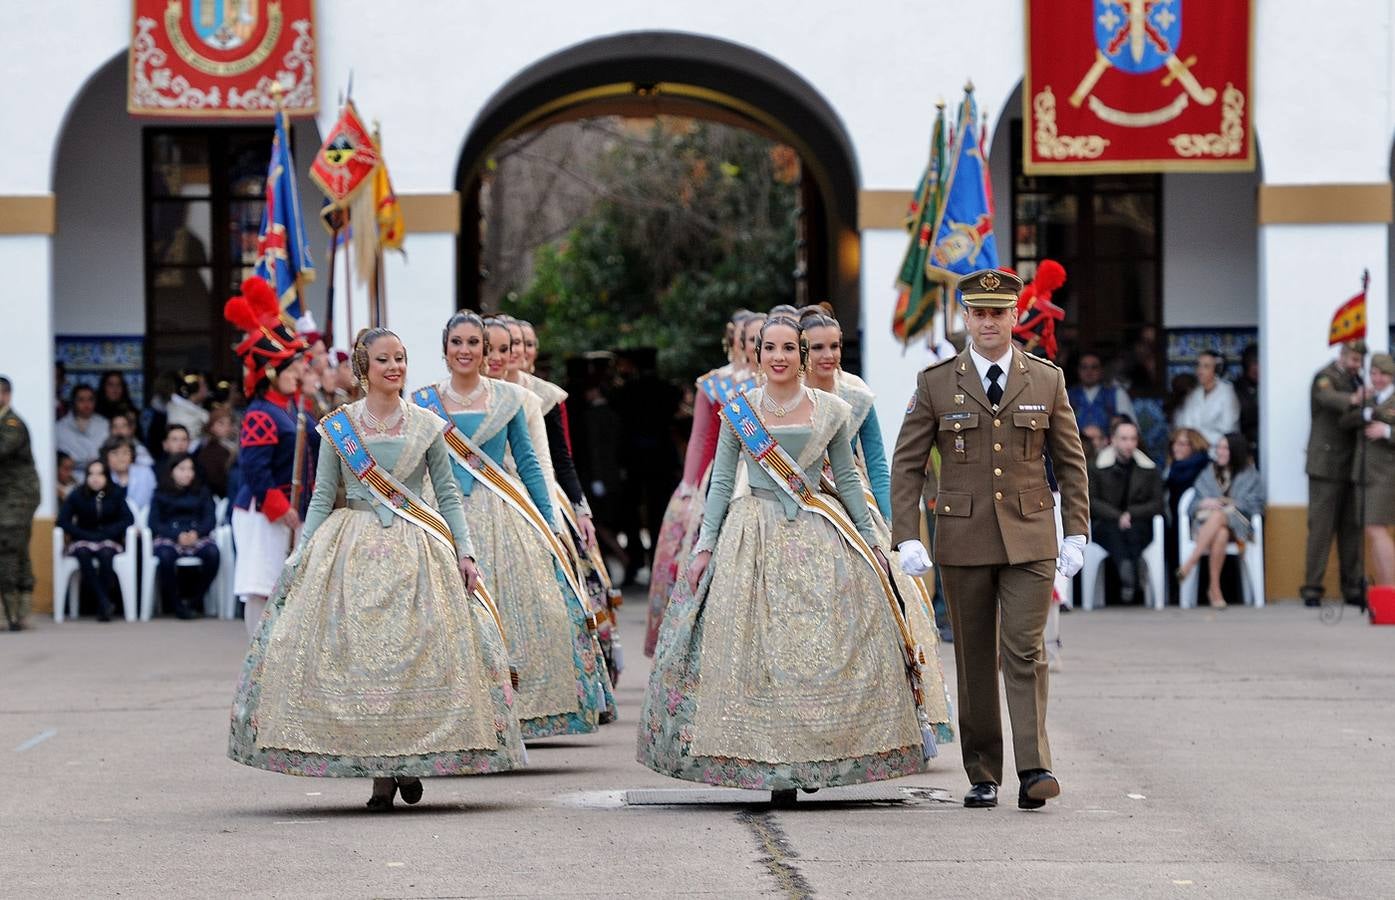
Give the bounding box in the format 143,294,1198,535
1023,0,1256,174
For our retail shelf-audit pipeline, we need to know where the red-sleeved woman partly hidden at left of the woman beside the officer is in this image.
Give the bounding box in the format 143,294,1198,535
644,310,766,656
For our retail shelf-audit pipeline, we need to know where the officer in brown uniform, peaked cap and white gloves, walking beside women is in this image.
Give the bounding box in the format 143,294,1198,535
891,269,1089,809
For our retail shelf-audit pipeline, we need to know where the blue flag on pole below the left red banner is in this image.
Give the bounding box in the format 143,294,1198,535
257,110,315,321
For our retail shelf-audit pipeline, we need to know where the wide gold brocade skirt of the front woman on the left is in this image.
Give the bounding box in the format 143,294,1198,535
227,509,525,777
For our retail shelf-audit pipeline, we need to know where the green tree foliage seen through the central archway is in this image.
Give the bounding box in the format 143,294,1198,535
505,120,798,380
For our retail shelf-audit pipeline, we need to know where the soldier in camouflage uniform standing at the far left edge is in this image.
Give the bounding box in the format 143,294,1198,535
0,377,39,631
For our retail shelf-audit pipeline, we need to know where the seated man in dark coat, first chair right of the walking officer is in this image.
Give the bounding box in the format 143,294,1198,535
1089,420,1162,603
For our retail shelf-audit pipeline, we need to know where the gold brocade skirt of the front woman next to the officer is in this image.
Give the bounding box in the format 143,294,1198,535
638,495,925,790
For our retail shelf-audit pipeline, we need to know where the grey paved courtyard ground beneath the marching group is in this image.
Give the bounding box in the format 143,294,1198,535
0,596,1395,900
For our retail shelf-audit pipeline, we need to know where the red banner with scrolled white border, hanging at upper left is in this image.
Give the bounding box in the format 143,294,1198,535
126,0,318,119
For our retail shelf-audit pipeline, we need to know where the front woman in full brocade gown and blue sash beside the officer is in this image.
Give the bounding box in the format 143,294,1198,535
639,317,933,802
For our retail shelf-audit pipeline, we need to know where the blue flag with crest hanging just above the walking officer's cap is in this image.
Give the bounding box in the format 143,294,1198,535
926,88,997,293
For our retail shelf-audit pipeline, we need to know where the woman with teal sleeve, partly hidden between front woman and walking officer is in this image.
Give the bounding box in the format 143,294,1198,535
799,307,954,742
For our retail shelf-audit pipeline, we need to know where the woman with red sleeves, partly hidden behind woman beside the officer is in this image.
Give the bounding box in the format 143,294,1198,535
644,310,751,656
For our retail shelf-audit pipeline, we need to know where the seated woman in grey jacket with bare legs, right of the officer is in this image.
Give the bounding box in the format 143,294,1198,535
1177,431,1264,608
